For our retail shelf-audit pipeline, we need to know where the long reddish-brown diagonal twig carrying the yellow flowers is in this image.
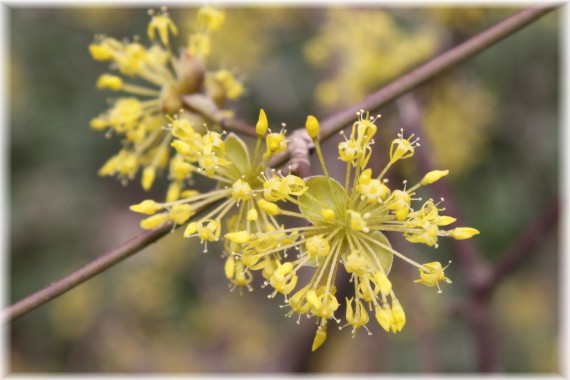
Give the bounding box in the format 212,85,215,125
2,2,555,322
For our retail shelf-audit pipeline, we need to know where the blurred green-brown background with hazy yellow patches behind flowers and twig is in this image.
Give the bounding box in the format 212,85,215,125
7,7,560,373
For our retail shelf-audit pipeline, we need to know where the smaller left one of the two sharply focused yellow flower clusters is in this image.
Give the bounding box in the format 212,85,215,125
131,110,292,268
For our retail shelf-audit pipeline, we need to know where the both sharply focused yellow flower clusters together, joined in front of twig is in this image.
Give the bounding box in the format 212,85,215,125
131,110,479,350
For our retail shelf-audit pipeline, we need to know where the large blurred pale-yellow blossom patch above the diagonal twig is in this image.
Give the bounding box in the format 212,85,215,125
305,9,437,107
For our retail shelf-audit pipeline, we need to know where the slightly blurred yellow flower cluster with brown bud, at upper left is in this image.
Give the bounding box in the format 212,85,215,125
89,7,244,193
